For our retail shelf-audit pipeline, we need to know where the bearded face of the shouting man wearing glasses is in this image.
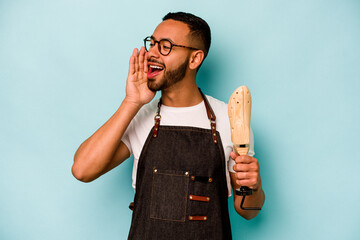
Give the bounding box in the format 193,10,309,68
147,20,190,91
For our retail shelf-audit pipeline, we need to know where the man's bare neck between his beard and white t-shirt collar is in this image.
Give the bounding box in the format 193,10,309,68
161,75,203,107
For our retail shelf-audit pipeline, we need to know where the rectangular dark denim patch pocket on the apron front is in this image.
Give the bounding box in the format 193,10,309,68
150,169,189,222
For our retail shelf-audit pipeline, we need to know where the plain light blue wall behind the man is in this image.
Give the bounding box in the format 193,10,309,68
0,0,360,240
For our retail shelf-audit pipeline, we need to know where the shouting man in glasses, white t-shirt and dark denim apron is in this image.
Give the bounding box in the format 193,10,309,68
72,12,265,239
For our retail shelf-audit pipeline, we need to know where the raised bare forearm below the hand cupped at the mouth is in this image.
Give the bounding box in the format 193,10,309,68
72,98,142,182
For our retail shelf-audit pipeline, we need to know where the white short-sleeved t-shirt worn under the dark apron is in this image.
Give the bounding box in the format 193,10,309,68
122,96,255,196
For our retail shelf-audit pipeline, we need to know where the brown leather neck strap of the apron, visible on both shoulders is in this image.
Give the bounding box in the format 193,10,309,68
153,88,217,144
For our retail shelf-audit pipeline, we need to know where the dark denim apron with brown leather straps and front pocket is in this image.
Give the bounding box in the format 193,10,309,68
128,93,231,240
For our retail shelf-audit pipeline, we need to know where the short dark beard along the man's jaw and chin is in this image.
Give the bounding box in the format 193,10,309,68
148,57,189,92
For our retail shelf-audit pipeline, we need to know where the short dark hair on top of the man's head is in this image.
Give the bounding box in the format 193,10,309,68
163,12,211,59
